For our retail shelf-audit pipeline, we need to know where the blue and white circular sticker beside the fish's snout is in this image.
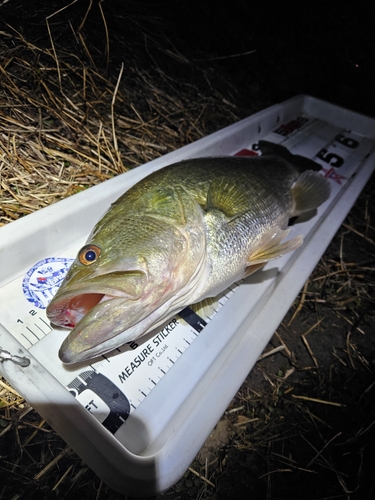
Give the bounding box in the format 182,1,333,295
22,257,74,309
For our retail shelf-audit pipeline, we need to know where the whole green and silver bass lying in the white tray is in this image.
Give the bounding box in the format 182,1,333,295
47,141,330,364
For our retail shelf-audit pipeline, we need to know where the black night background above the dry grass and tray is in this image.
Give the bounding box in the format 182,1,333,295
0,0,375,115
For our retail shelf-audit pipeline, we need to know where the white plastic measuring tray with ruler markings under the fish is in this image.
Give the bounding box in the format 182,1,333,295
0,96,375,496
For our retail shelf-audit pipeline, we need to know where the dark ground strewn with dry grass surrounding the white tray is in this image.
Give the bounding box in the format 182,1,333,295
0,0,375,500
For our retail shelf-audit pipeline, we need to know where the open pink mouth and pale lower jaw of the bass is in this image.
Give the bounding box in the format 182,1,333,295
47,273,159,364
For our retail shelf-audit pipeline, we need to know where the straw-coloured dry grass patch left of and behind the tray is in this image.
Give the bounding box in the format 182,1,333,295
0,19,250,225
